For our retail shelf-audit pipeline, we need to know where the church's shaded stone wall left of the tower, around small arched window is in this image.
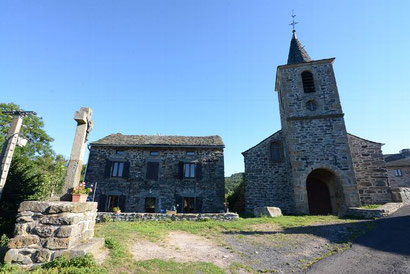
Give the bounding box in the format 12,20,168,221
243,131,294,213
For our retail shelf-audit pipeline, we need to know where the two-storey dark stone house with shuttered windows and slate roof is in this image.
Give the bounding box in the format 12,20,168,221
85,133,225,213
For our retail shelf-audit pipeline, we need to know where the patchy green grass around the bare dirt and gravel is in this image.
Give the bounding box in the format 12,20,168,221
0,216,370,274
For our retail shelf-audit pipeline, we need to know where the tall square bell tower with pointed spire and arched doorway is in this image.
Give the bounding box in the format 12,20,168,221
275,25,360,214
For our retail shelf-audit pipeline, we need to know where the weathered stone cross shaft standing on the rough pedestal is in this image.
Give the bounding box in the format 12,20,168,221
60,107,93,201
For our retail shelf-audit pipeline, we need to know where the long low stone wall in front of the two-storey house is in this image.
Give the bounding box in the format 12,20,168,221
96,212,239,223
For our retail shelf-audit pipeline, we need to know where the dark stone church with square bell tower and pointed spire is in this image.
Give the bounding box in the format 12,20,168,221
242,31,391,214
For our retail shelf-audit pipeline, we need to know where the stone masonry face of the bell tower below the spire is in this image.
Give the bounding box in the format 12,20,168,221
277,59,360,213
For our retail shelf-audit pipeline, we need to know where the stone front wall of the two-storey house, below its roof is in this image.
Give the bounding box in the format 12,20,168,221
86,146,225,213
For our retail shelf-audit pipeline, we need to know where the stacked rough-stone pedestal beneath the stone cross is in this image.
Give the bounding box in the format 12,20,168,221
4,201,97,266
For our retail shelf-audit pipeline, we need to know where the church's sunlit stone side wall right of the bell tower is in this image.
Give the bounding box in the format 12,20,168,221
348,134,392,205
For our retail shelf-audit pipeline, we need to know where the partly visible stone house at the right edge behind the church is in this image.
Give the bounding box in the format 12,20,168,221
384,149,410,187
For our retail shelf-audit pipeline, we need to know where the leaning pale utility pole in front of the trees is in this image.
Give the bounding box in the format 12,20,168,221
0,110,37,200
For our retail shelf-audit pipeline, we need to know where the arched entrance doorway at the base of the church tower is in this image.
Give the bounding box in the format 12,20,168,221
306,168,343,215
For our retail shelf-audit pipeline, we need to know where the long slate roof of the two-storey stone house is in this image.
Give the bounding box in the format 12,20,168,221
91,133,225,148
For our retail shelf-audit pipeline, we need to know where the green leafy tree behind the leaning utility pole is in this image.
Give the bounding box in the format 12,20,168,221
0,103,66,236
